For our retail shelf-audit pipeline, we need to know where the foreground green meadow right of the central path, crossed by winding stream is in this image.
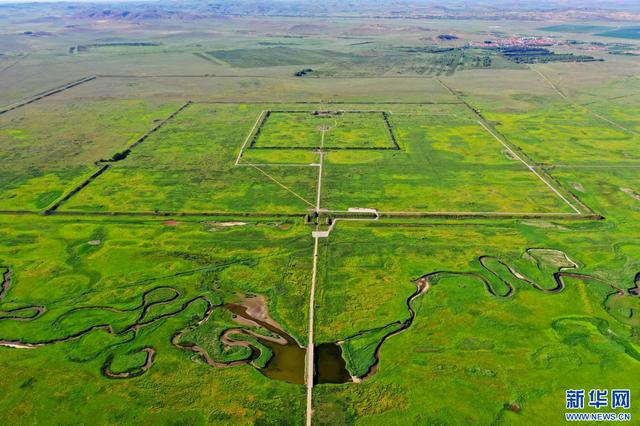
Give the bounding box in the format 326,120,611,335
315,221,640,424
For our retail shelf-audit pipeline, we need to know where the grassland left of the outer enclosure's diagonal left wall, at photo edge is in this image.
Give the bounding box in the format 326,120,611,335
0,99,178,210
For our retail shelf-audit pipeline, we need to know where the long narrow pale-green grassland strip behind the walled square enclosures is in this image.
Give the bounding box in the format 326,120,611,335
51,75,456,104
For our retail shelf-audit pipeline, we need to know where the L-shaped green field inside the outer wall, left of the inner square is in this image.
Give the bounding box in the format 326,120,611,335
63,104,317,215
